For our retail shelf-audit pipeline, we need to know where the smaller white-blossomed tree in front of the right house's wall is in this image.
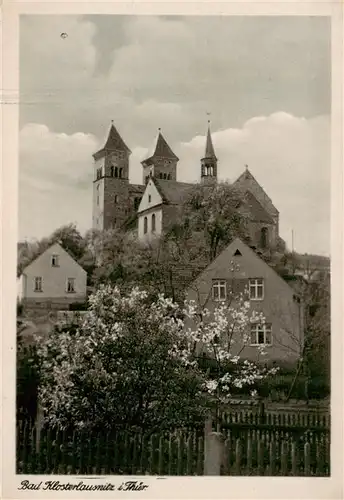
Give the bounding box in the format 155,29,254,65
185,284,278,420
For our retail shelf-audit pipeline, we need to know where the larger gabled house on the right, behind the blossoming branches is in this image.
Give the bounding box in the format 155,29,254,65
186,238,303,364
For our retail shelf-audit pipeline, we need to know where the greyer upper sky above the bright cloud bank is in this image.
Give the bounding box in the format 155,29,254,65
20,16,331,143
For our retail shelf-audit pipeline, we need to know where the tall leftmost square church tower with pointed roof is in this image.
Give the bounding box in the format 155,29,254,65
92,121,131,231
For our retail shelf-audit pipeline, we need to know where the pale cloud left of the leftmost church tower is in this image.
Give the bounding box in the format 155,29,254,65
19,123,97,242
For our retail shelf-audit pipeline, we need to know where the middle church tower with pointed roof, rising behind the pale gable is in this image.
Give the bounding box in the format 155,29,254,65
141,128,179,184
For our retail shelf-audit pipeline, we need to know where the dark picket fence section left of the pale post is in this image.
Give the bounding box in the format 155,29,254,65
17,424,204,476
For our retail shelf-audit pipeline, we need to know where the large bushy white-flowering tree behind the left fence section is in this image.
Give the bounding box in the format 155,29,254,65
38,285,208,430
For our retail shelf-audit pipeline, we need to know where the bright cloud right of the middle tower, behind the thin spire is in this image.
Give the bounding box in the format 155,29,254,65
177,112,331,254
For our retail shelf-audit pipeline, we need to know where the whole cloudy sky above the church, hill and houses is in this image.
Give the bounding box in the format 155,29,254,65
19,15,331,255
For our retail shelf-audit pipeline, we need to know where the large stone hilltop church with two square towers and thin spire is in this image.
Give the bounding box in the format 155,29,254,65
92,122,284,250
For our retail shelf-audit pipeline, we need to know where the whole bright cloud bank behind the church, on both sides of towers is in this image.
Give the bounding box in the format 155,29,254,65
20,112,330,254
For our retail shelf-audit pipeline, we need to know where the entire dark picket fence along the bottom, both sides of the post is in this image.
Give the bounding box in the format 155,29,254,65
17,412,330,476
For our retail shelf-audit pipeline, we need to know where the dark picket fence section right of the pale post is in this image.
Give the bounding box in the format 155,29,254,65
219,411,330,476
